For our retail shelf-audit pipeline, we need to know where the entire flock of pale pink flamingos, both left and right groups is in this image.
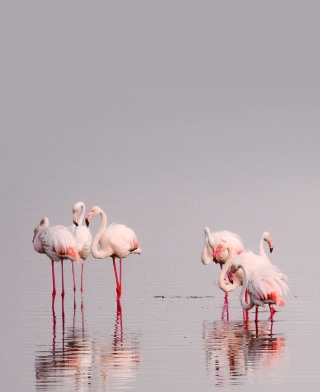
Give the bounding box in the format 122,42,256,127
32,202,288,322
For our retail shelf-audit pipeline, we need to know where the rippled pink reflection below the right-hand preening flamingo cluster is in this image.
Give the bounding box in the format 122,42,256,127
203,320,285,387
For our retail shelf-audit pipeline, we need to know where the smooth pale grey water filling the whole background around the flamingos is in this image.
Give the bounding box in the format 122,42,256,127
0,2,320,392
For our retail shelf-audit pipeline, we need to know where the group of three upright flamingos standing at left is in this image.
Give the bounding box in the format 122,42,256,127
32,202,141,304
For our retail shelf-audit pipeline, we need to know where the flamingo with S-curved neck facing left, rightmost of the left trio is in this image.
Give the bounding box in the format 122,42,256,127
86,206,141,300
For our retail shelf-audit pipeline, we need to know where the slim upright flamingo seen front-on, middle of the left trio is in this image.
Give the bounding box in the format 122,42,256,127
70,201,92,292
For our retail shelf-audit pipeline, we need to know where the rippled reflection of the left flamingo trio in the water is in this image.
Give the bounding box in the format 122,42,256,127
35,301,140,392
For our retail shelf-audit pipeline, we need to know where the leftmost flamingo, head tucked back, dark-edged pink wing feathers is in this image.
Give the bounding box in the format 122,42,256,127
32,218,81,299
